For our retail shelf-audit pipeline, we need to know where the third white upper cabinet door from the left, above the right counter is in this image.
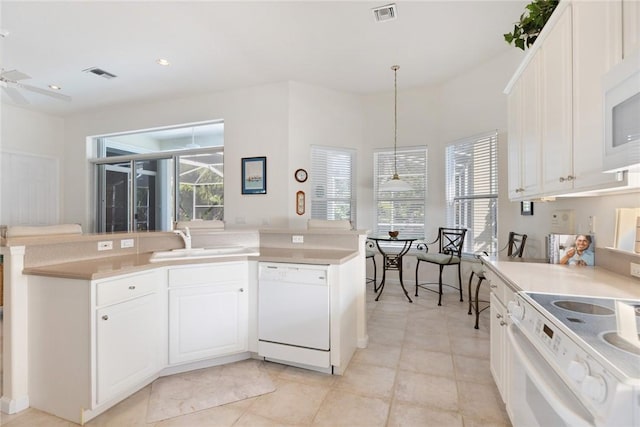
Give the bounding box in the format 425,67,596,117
540,4,574,194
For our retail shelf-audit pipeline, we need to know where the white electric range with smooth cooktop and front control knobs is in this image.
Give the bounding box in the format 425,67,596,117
507,292,640,427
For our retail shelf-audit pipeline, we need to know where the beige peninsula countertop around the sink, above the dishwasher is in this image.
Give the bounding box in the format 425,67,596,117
23,248,358,280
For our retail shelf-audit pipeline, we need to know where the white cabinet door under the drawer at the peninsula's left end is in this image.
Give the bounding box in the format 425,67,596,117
96,293,161,404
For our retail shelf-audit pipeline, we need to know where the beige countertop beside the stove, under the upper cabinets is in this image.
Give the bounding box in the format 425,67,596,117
483,258,640,299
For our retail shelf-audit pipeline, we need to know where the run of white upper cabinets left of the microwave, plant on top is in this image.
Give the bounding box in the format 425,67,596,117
505,0,640,200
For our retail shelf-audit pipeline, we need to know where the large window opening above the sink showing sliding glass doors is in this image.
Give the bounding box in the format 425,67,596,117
92,122,224,232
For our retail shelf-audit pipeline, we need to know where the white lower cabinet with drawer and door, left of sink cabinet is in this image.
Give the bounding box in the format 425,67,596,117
28,269,167,424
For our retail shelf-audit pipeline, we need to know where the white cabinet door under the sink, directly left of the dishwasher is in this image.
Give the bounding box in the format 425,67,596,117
169,283,249,364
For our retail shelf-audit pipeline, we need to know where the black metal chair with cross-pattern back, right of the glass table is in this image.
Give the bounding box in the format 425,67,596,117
416,227,467,305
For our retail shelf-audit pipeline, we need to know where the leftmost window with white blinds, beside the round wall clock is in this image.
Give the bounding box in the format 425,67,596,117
310,146,356,227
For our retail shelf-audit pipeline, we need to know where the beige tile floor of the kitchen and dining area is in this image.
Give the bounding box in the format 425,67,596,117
0,284,510,427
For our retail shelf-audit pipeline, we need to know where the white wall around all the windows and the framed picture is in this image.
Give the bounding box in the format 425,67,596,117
0,49,640,257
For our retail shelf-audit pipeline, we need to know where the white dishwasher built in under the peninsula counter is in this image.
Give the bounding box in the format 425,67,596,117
258,262,331,371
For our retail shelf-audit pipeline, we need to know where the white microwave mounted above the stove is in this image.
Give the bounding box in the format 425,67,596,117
603,51,640,172
